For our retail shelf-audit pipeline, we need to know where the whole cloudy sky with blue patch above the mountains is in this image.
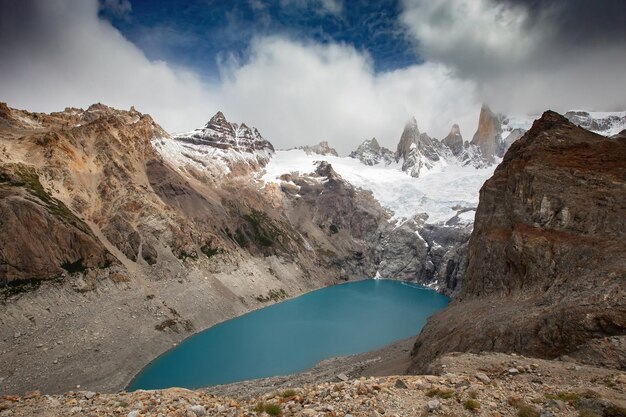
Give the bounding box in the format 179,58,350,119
0,0,626,154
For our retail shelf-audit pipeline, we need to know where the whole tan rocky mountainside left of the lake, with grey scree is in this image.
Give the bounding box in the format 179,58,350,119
0,104,386,392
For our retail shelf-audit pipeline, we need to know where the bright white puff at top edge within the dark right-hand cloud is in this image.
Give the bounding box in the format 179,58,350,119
401,0,543,77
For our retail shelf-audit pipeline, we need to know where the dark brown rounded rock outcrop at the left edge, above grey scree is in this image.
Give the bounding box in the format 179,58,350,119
0,165,113,285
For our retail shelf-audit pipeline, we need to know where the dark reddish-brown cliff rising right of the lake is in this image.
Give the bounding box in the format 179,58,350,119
412,112,626,370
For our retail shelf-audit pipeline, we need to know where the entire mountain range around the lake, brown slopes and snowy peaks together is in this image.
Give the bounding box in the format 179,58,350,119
0,98,626,393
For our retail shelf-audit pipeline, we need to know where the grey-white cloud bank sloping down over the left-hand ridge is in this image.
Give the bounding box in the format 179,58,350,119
0,0,218,131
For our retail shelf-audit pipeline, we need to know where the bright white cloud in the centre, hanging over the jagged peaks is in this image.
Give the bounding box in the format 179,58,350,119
222,37,479,154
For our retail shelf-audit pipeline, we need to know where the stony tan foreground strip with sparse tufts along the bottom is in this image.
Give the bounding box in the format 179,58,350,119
0,353,626,417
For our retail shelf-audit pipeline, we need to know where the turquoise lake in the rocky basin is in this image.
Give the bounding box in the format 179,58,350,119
128,279,448,391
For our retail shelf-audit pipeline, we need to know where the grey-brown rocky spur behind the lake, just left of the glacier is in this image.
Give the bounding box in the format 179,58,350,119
281,161,391,279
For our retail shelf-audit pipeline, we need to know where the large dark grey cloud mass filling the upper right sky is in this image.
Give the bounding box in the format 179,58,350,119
400,0,626,113
